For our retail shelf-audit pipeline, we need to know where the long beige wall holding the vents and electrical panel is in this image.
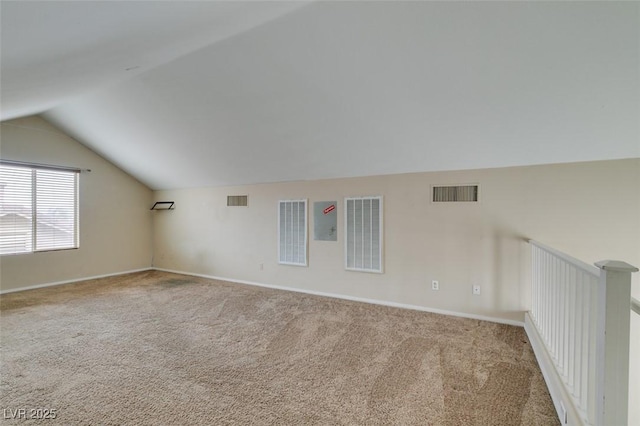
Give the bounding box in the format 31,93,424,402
153,159,640,321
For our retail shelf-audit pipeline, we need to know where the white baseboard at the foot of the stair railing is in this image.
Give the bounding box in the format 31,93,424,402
524,312,585,425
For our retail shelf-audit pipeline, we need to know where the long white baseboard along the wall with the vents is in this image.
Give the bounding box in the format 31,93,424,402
153,267,524,327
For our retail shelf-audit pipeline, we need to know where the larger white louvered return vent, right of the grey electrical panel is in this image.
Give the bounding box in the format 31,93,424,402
344,197,382,272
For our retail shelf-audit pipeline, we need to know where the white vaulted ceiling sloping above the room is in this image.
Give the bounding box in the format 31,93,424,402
0,0,640,189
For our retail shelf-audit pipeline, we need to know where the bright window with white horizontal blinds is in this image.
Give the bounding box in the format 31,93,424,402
0,164,79,254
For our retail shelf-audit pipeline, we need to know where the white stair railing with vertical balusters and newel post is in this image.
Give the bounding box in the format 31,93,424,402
525,241,638,426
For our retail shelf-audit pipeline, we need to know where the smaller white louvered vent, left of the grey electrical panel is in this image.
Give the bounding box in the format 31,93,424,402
278,200,307,266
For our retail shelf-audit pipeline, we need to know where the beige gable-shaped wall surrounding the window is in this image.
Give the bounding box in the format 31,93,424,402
0,117,153,291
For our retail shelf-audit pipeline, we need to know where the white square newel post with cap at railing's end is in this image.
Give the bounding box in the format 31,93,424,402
595,260,638,425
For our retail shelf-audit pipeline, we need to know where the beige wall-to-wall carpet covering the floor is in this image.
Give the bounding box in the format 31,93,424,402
0,272,558,425
